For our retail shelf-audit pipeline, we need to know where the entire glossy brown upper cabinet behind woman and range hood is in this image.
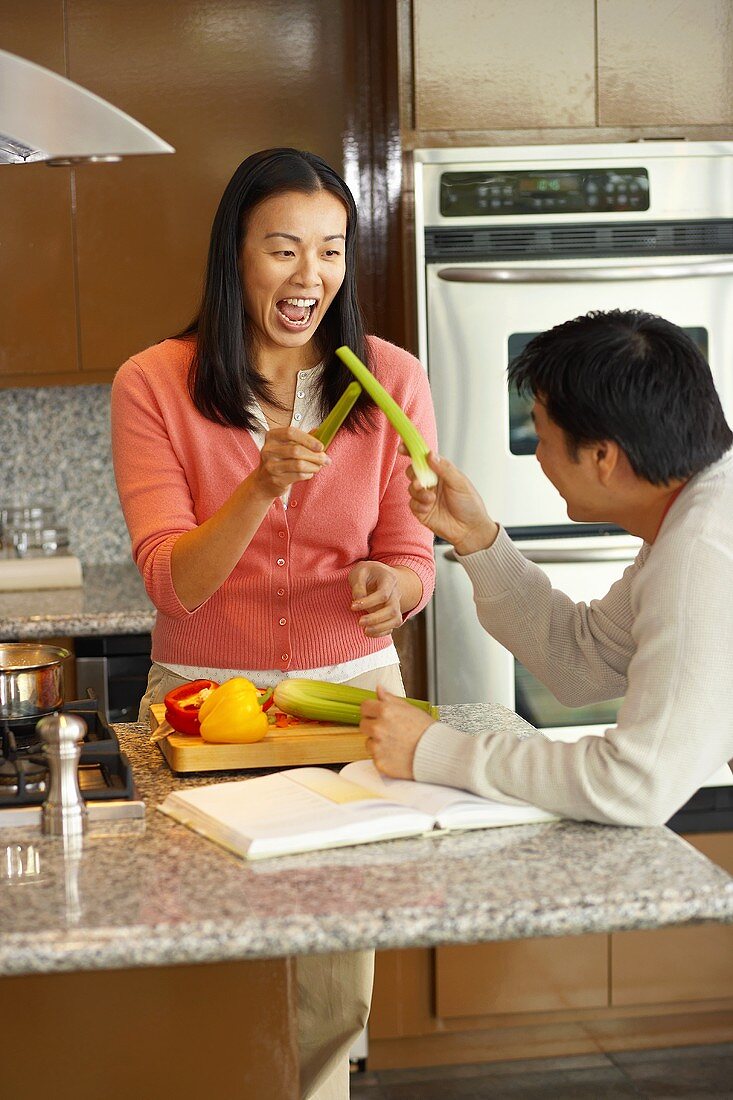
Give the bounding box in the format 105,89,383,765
0,0,350,387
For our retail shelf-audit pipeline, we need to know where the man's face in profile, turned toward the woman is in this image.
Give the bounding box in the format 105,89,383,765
532,397,604,523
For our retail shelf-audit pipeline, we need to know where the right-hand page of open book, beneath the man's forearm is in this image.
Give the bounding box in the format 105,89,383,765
339,760,557,828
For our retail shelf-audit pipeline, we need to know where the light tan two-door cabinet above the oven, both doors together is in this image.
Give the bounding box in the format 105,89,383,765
403,0,733,137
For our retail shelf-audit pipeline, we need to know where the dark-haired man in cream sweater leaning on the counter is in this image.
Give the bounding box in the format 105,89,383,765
362,310,733,825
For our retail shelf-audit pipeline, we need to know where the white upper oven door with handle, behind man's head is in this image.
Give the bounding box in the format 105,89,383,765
426,256,733,532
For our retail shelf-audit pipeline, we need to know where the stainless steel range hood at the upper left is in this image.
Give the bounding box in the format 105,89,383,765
0,50,175,165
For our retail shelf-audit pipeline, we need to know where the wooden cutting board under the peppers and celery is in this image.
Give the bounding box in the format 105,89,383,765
150,703,369,772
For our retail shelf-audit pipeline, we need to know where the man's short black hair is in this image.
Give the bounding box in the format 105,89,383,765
508,309,733,485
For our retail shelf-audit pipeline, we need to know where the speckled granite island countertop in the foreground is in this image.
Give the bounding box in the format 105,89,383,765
0,704,733,975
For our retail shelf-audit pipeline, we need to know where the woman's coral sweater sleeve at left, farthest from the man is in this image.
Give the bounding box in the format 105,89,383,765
111,359,196,619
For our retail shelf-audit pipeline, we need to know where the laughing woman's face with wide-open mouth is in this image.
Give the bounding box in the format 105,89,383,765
240,191,347,351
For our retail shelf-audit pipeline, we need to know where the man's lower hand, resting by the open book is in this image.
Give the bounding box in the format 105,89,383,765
359,688,435,779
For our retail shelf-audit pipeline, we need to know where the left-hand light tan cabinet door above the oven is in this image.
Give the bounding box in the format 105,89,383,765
413,0,595,131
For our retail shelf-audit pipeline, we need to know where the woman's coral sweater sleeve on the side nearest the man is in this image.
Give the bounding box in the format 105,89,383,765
360,341,437,619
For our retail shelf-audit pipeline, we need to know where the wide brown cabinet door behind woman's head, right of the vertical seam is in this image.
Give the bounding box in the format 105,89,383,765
68,0,348,376
